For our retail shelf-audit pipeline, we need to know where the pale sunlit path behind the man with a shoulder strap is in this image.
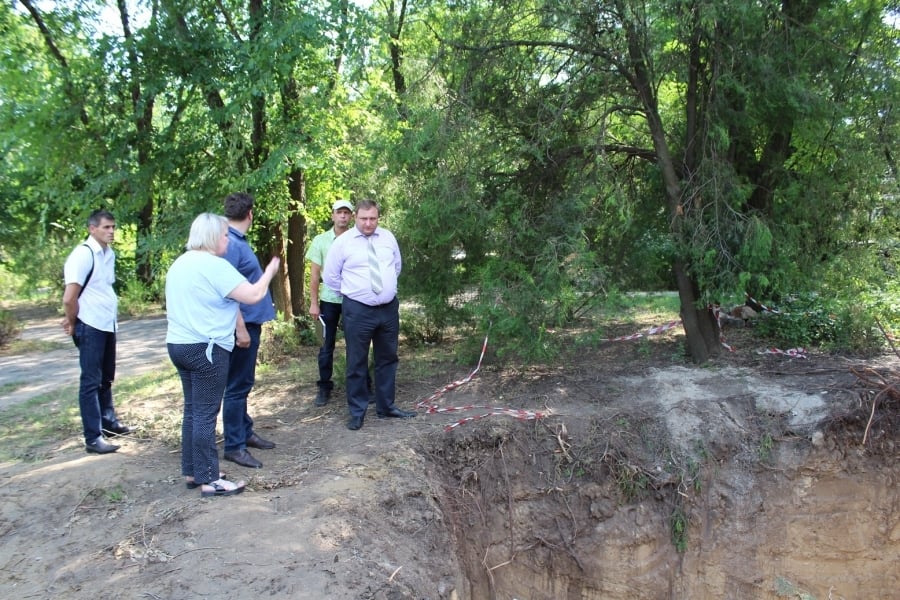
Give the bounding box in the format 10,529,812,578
0,316,169,411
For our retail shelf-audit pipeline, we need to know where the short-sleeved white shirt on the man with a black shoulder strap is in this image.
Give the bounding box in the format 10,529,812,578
63,237,119,332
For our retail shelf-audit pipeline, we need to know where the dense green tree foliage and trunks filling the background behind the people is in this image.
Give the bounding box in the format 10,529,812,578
0,0,900,361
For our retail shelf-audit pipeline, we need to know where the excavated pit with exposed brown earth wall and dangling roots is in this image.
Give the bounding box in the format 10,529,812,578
425,402,900,600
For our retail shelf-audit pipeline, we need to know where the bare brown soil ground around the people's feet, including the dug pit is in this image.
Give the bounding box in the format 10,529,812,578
0,308,900,600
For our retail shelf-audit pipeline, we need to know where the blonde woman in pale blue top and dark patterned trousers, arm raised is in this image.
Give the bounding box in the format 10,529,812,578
166,213,280,496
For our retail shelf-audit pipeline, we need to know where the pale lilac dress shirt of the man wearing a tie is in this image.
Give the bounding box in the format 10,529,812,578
322,227,402,306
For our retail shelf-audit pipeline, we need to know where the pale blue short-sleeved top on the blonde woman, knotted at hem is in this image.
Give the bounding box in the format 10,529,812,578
166,250,246,362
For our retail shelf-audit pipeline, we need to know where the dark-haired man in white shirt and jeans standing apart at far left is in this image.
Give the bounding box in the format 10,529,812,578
63,210,132,454
